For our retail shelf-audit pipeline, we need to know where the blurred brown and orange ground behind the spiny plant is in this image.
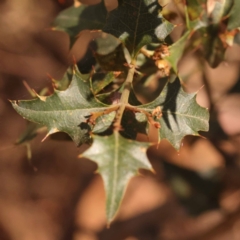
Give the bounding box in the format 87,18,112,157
0,0,240,240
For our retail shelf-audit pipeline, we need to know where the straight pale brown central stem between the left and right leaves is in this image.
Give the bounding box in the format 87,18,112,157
114,64,135,131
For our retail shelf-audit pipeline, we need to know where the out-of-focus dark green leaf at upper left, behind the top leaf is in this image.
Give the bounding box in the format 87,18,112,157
53,1,107,47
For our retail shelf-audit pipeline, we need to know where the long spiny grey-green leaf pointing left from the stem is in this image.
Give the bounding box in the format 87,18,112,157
12,66,115,145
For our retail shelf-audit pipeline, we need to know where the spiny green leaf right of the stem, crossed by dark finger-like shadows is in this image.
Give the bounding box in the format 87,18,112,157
139,79,209,150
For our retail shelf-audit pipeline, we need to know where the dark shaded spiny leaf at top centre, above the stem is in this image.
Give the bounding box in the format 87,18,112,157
103,0,174,57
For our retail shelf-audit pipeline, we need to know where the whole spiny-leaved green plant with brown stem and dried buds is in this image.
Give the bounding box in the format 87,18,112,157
12,0,240,224
